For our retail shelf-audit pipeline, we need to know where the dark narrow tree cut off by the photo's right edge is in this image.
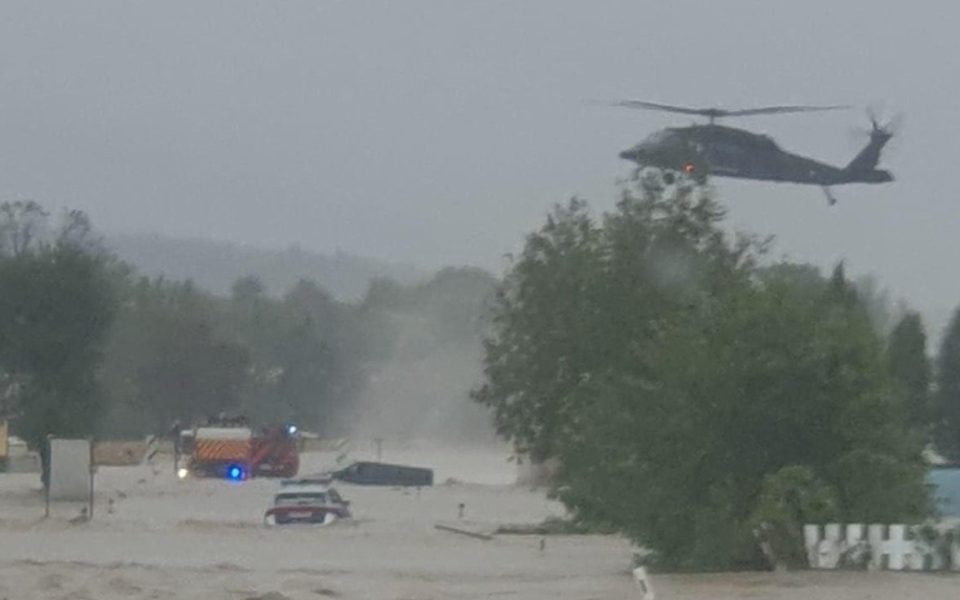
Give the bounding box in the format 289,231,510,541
935,307,960,460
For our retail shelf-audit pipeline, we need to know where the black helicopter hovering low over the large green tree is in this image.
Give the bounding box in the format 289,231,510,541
614,100,893,205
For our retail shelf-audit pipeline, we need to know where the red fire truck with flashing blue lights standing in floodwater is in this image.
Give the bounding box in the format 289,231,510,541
177,425,300,481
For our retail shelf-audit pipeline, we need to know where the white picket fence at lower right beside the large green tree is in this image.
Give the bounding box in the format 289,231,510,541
803,523,960,571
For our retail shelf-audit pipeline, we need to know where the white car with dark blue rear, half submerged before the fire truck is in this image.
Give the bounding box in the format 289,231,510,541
263,479,351,525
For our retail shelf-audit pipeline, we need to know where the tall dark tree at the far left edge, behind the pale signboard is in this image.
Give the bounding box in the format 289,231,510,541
0,203,116,446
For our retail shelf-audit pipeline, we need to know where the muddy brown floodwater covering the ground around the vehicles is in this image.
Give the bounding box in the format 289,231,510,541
0,444,960,600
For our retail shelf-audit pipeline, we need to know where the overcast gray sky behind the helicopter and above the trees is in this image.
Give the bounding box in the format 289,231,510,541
0,0,960,328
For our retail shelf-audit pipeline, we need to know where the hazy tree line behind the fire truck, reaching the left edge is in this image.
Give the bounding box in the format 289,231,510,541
0,201,493,447
